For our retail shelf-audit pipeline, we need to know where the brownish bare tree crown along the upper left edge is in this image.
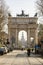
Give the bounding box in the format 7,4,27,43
0,0,8,32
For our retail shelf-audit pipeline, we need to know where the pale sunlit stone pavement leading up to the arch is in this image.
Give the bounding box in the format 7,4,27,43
0,50,43,65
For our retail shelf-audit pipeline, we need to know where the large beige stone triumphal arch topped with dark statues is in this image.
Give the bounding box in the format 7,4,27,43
8,11,38,47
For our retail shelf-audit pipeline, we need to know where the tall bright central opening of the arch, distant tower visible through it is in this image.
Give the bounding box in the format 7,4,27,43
18,30,27,48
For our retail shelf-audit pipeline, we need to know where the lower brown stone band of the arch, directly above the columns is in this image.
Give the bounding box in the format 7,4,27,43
9,24,38,29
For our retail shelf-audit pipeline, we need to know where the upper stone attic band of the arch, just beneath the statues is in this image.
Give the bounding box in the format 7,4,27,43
9,17,37,24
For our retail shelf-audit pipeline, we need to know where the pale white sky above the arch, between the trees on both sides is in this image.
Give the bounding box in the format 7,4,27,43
5,0,36,16
